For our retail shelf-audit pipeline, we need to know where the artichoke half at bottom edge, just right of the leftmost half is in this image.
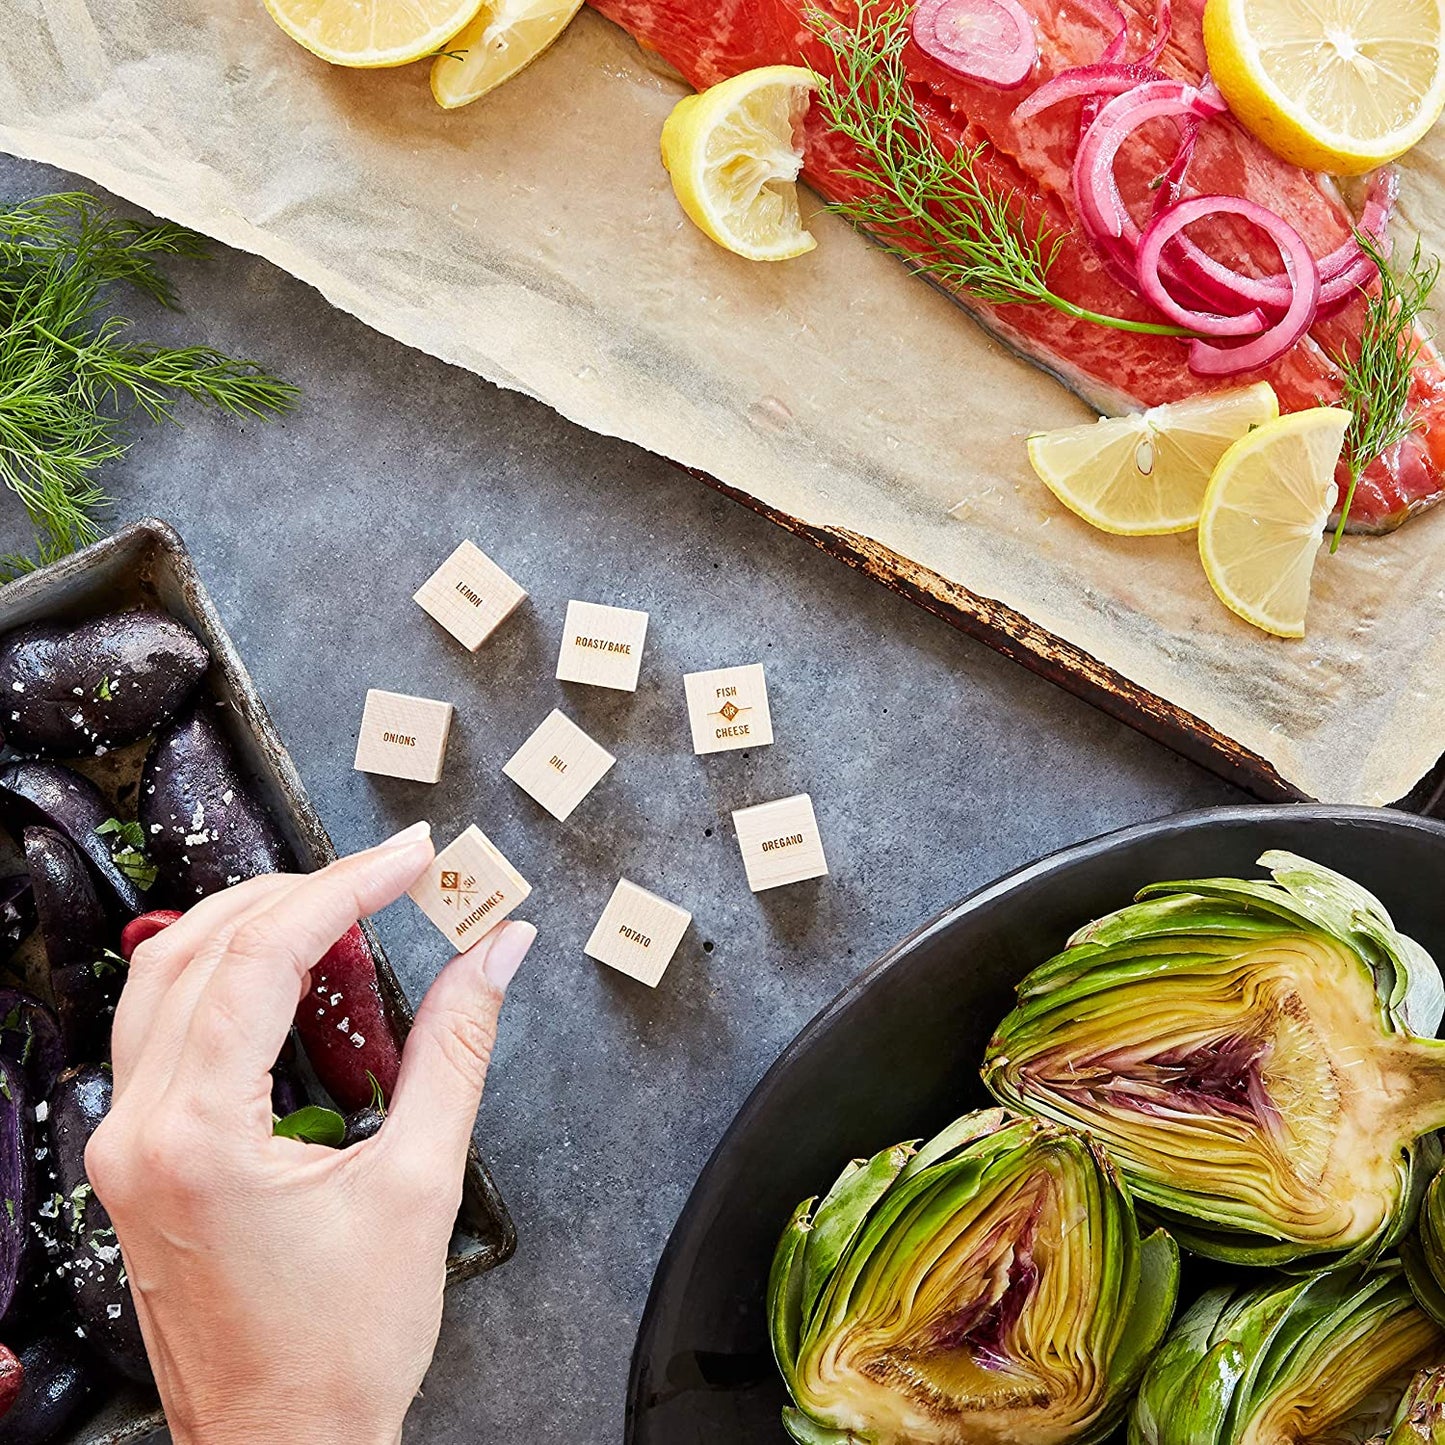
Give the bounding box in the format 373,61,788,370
1129,1261,1445,1445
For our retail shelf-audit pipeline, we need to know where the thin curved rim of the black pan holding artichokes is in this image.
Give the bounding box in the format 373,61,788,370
624,803,1445,1442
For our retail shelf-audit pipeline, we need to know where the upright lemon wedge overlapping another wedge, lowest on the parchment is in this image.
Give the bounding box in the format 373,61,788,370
1199,406,1350,637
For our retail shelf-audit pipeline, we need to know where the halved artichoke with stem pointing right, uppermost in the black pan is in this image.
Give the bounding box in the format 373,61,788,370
984,853,1445,1267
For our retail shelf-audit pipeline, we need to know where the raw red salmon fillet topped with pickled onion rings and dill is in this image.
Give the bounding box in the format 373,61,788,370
590,0,1445,532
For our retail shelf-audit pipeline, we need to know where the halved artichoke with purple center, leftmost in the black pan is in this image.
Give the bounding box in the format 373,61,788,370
767,1108,1179,1445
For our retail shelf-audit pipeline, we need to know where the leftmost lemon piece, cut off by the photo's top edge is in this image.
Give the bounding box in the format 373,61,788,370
266,0,480,69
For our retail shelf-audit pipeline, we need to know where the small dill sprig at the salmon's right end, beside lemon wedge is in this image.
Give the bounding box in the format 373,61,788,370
1329,234,1441,552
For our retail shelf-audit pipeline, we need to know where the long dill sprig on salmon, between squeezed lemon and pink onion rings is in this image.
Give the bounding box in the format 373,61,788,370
805,0,1192,337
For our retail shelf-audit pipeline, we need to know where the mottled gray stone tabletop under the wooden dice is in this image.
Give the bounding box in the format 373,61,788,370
0,159,1240,1445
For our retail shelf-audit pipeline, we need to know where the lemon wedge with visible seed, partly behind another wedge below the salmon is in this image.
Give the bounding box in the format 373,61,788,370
1029,381,1279,536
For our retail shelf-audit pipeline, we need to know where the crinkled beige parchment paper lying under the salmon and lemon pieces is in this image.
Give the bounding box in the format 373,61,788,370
0,0,1445,803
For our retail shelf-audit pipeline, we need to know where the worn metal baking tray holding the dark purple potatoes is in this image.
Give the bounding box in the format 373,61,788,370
0,519,516,1445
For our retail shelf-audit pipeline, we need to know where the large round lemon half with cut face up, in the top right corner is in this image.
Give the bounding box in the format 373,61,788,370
1204,0,1445,175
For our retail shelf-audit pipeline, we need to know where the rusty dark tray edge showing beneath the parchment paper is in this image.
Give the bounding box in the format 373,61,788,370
681,467,1312,802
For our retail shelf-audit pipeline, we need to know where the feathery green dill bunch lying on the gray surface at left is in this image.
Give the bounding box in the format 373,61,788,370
0,192,299,577
